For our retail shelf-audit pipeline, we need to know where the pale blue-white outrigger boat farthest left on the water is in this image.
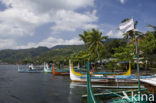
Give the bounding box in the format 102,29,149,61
18,64,43,73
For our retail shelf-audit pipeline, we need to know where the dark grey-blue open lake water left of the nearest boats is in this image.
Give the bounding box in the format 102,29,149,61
0,65,85,103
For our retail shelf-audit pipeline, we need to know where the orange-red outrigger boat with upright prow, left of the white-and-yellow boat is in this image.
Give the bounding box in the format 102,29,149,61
52,64,69,75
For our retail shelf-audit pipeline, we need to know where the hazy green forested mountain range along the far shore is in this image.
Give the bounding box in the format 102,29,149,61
0,38,120,64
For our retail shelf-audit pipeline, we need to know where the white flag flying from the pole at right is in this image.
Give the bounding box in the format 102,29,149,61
119,18,134,33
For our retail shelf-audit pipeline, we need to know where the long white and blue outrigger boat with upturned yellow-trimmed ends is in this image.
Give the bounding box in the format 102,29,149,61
69,62,153,83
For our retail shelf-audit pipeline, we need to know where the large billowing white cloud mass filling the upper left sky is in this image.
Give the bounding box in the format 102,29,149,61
0,0,98,49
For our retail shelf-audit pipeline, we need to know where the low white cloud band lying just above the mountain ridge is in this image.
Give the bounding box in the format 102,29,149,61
0,37,83,49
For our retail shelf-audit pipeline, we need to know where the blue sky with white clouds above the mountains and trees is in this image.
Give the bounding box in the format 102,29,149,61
0,0,156,50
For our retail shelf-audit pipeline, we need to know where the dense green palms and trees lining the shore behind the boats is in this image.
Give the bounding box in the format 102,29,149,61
71,18,156,69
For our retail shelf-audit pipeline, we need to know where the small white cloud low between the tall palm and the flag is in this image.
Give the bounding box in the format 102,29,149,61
106,30,123,38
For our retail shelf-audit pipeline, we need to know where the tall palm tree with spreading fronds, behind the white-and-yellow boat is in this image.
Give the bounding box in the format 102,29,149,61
79,29,107,61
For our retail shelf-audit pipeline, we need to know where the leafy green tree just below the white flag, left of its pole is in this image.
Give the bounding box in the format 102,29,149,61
113,18,142,70
